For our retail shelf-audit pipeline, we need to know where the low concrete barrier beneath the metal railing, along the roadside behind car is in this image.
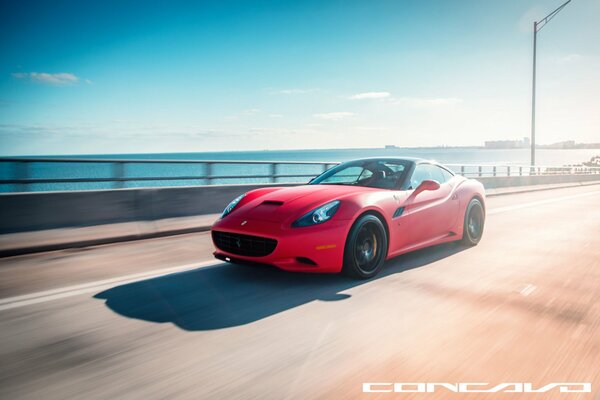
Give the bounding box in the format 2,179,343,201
0,175,600,234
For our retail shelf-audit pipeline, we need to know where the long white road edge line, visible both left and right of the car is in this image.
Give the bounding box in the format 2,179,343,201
0,190,600,311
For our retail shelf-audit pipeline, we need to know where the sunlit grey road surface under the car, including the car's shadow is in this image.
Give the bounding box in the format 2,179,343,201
0,185,600,400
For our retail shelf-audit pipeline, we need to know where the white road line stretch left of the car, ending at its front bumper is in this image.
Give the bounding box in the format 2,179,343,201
0,260,223,311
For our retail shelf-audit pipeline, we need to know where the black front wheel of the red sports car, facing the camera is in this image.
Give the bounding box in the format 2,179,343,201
343,214,388,279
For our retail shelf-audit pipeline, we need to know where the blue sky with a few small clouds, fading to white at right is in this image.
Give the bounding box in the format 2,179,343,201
0,0,600,155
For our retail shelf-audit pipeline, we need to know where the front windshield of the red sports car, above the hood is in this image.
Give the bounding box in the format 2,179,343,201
310,160,409,189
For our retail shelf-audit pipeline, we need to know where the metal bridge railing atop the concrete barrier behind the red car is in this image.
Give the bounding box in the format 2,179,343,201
0,157,600,192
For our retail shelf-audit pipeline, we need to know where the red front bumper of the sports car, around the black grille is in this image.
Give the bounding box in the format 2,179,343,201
212,215,351,273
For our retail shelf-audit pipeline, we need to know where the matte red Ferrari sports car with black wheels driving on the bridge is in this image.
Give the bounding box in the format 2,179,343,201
212,158,485,279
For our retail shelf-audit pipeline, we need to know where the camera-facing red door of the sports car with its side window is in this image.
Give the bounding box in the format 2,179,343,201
396,163,458,249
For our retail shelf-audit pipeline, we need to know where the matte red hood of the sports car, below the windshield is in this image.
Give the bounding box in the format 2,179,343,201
235,185,374,222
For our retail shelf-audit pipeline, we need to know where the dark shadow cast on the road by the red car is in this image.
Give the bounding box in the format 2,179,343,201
94,243,466,331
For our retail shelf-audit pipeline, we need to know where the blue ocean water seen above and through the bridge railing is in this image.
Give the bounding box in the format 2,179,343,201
0,148,600,192
